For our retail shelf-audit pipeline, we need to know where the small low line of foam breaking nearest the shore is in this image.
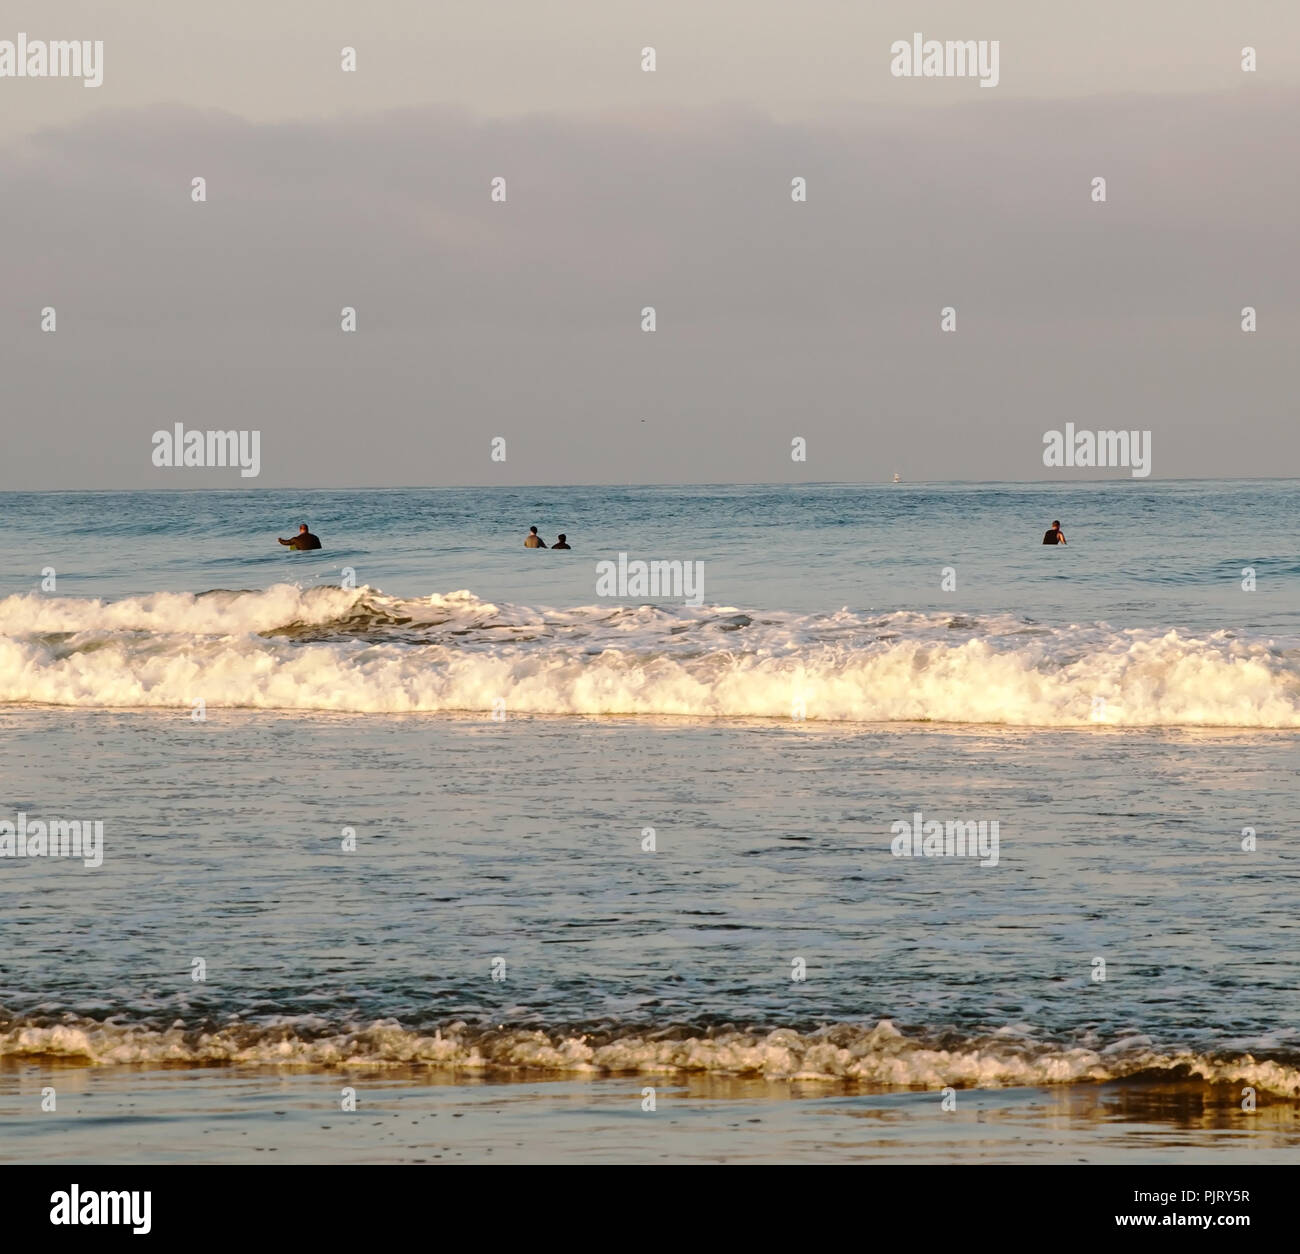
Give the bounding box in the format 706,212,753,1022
0,1020,1300,1099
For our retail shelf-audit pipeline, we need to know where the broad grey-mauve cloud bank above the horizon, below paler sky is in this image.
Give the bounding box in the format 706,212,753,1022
0,87,1300,487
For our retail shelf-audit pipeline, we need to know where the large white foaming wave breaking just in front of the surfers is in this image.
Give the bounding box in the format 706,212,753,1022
0,585,1300,728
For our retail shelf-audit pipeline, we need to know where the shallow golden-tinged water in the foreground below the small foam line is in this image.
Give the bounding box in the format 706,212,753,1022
0,1064,1300,1164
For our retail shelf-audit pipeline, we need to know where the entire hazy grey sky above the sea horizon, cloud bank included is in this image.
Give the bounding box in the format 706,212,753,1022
0,0,1300,490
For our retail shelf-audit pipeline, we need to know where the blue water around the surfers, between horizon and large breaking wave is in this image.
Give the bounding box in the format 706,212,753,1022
0,480,1300,632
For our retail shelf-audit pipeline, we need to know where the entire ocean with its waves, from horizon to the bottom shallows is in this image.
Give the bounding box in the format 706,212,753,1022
0,480,1300,1162
